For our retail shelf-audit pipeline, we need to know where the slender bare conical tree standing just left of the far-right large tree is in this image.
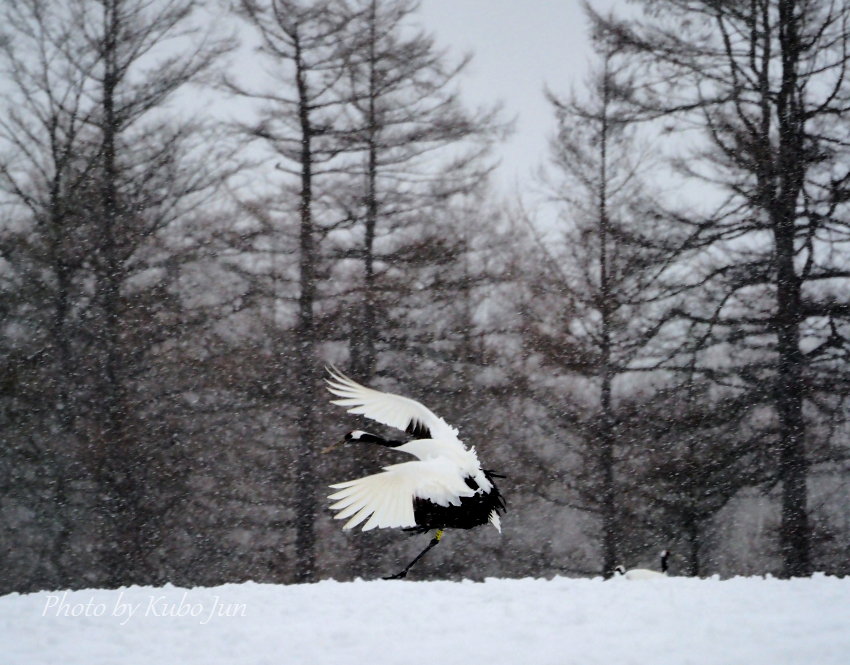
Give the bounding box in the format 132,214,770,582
524,45,676,575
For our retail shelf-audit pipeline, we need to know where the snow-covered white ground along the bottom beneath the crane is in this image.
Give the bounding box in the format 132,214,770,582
0,575,850,665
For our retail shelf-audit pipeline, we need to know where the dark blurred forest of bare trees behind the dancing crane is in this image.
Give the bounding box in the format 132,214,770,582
0,0,850,592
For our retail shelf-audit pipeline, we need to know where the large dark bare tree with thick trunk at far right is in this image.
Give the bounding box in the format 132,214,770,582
593,0,850,576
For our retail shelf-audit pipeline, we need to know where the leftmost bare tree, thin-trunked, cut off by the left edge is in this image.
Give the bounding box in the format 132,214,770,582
0,2,106,585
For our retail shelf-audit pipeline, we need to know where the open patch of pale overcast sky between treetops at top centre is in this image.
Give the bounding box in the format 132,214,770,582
412,0,623,188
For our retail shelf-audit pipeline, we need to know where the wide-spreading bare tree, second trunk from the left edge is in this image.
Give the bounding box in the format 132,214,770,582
2,0,228,585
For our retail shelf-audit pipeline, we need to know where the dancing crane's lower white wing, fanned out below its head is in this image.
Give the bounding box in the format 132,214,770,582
328,459,475,531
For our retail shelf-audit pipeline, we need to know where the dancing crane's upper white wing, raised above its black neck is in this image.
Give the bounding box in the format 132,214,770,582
326,367,462,445
